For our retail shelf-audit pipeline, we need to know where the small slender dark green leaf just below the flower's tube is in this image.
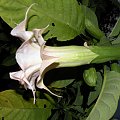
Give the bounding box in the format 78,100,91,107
50,79,75,88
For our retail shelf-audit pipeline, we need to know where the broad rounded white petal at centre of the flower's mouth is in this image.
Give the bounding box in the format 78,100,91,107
16,41,42,70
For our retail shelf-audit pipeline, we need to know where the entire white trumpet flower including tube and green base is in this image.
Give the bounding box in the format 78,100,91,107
10,5,120,103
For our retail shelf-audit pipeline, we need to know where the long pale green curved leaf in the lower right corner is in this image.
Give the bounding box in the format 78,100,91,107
86,71,120,120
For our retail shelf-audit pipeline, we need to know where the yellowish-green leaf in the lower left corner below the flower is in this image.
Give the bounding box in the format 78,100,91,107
0,90,53,120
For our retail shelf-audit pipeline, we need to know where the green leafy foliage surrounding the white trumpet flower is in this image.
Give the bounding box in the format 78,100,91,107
0,0,120,120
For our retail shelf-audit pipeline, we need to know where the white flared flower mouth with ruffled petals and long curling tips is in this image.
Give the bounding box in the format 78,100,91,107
10,5,61,103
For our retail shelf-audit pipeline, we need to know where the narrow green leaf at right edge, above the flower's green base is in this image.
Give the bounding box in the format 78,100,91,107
109,17,120,37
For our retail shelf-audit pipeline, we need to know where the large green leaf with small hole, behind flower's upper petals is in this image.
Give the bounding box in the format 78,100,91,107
0,0,84,40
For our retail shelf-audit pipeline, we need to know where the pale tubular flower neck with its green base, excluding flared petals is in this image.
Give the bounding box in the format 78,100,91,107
44,46,120,67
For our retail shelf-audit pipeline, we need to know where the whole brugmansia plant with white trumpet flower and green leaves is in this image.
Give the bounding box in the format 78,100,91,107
0,0,120,120
